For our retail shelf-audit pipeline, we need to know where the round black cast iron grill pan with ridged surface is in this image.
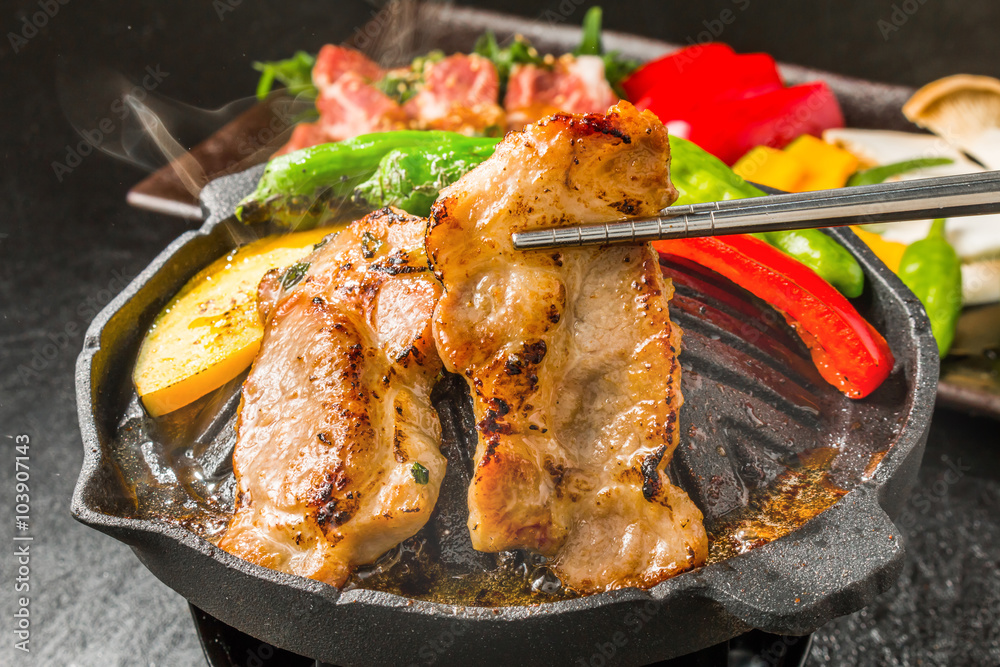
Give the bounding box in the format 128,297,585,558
72,154,938,665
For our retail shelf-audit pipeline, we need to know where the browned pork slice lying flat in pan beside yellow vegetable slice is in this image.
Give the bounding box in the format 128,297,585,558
225,209,445,586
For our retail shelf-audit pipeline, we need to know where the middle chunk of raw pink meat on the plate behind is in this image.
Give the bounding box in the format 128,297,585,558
404,53,506,134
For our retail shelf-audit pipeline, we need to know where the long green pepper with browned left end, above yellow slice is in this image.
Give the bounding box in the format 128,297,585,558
236,130,498,229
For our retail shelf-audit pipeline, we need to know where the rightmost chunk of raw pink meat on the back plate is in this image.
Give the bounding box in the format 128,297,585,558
503,54,618,130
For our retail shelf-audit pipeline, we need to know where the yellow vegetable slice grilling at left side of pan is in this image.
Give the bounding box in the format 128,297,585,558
133,229,334,417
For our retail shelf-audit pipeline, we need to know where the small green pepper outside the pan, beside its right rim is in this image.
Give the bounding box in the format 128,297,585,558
898,219,962,357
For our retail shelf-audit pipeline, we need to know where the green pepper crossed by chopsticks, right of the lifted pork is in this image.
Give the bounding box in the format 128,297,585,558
670,136,865,297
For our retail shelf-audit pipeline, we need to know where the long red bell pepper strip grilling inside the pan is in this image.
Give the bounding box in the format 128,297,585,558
653,234,895,398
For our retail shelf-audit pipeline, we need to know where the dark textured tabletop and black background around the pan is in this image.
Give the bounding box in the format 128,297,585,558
0,0,1000,666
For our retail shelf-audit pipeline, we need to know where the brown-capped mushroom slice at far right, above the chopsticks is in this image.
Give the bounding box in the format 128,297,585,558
903,74,1000,169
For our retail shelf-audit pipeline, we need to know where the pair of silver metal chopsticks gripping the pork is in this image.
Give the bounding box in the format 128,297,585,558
512,171,1000,250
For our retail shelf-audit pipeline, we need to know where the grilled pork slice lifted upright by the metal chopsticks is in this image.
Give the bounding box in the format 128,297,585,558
427,102,707,592
